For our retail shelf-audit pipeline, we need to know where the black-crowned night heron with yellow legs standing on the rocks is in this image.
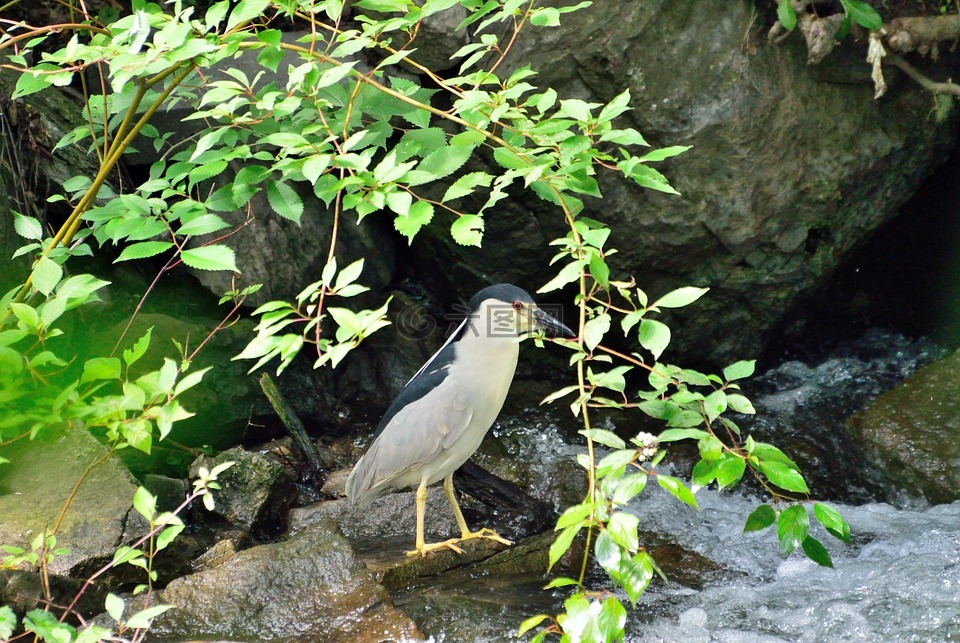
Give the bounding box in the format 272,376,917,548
347,284,574,556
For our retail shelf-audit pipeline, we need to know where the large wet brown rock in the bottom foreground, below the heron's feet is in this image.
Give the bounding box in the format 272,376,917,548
152,522,422,643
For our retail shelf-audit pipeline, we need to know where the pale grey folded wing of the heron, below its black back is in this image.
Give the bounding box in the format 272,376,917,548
347,378,473,505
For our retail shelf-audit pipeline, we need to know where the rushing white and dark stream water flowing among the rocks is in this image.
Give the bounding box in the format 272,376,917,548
396,332,960,643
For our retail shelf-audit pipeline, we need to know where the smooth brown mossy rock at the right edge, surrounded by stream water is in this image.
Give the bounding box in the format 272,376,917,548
848,353,960,503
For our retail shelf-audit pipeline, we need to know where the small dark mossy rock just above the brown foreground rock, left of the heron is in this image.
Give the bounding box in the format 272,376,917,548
191,448,293,533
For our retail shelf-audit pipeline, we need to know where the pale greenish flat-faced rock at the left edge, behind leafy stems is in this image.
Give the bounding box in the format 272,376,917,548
0,429,147,574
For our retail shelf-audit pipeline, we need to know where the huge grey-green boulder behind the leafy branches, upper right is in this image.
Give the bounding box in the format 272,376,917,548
413,0,956,368
